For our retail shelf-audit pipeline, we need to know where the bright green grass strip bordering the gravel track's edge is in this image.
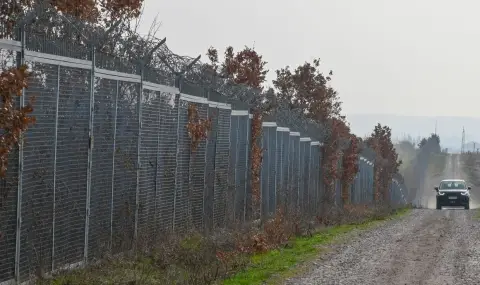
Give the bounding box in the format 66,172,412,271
223,208,409,285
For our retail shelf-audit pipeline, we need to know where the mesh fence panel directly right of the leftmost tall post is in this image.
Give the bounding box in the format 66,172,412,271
19,62,60,281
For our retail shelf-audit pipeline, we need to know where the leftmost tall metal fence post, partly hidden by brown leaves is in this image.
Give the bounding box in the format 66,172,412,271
15,26,25,284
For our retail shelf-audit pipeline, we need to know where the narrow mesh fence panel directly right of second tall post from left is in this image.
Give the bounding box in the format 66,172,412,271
88,78,119,258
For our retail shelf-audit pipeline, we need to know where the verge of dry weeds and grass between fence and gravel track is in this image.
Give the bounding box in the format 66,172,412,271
37,205,410,285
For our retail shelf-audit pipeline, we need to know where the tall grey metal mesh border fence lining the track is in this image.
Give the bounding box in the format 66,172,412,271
0,25,407,284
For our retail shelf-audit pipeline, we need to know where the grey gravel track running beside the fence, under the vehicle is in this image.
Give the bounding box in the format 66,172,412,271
287,156,480,285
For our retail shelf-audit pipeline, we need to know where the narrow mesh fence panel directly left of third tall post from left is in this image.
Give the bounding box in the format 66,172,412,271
112,81,140,253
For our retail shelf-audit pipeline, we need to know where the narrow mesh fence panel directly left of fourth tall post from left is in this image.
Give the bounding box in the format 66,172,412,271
156,92,179,235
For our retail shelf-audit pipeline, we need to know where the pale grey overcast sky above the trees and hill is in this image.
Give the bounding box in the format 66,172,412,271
135,0,480,117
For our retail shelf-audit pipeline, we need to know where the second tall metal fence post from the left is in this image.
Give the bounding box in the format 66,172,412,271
83,46,95,264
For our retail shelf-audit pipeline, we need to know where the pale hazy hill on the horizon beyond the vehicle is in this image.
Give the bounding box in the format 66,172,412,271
347,114,480,152
